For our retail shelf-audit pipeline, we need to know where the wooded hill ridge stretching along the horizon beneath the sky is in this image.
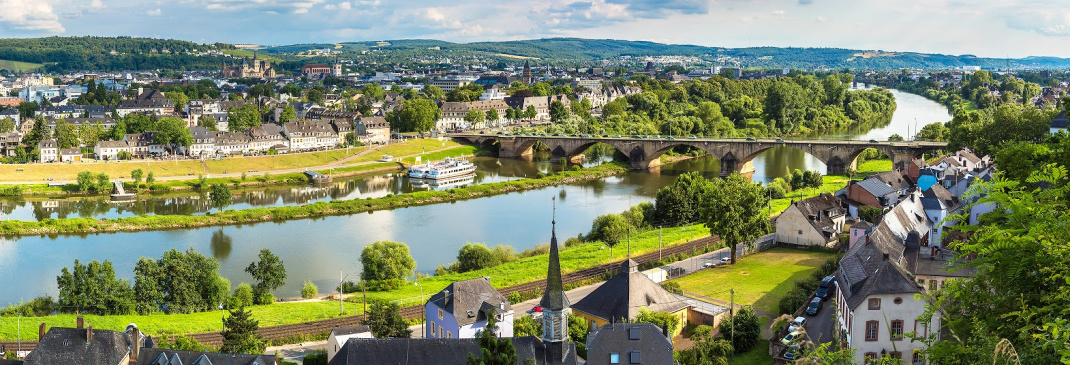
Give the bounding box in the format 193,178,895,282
0,36,1070,72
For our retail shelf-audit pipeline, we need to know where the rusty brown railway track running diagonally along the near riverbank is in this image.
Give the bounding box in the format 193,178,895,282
6,237,720,344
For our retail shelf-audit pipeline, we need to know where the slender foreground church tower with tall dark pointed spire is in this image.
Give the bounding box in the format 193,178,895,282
539,199,570,364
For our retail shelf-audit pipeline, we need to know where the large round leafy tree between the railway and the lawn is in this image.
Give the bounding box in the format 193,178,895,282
701,172,770,263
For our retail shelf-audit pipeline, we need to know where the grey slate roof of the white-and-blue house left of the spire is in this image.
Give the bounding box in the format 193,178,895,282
428,277,513,325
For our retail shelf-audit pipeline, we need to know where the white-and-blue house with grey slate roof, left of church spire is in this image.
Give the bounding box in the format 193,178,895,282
424,277,513,338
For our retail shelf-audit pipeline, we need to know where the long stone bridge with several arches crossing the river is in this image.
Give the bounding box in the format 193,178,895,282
449,134,947,176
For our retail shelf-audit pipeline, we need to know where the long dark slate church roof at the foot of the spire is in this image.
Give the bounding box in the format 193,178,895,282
330,336,578,365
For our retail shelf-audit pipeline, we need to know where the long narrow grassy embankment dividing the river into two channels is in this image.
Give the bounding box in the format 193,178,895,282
0,164,627,235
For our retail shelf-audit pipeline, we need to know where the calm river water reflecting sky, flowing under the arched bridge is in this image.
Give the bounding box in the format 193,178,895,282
0,90,949,304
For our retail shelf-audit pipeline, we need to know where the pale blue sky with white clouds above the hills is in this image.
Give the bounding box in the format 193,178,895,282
0,0,1070,58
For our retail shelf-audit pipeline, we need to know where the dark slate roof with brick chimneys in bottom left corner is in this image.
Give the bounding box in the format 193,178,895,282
26,326,132,365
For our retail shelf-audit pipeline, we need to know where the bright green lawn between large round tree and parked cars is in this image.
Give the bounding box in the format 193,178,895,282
674,247,835,313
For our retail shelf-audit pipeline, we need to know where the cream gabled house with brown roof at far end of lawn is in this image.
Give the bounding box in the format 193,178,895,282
776,194,846,247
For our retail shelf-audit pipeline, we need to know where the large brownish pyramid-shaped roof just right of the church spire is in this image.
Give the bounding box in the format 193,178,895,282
572,259,687,322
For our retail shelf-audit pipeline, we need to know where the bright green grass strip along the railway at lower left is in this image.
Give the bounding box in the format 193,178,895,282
0,301,363,341
